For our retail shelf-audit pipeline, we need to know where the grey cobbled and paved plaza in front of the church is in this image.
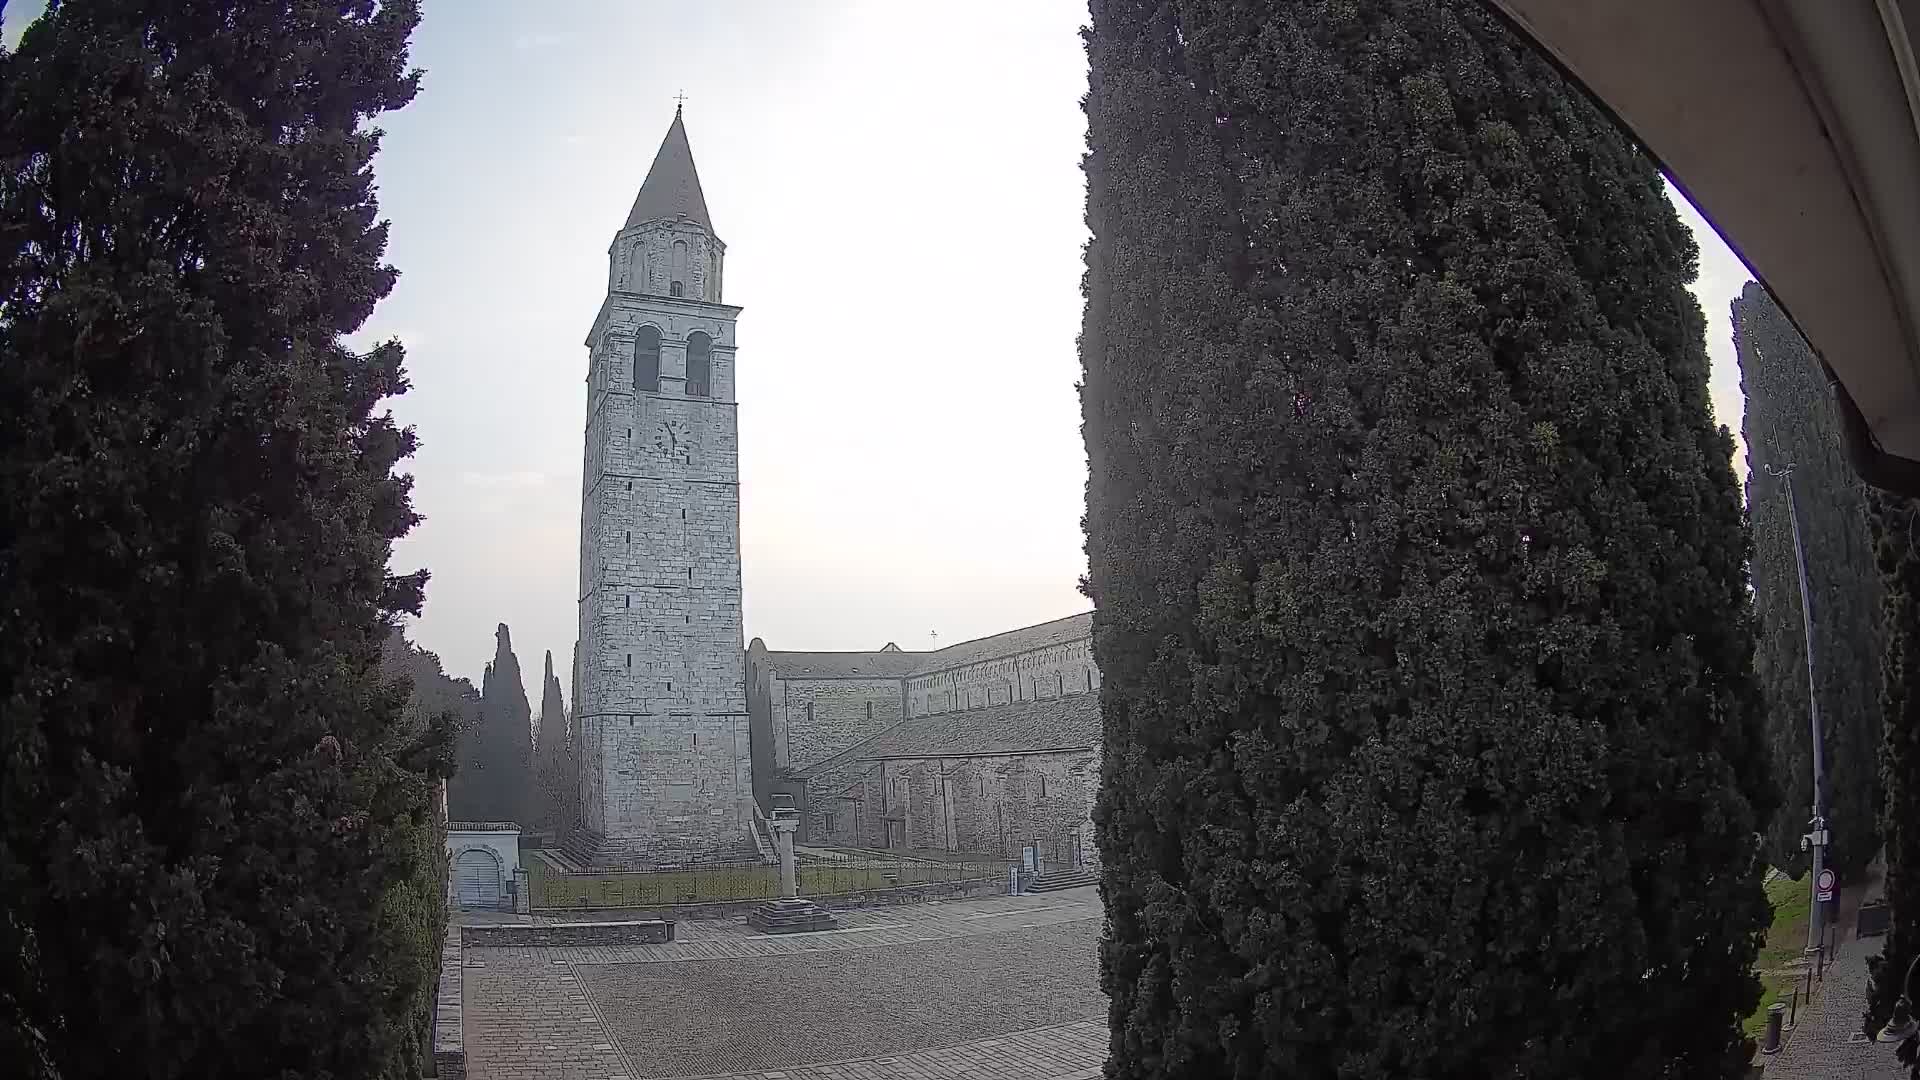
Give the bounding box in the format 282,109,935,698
461,888,1106,1080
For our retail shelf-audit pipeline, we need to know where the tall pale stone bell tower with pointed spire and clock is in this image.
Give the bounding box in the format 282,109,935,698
574,110,755,865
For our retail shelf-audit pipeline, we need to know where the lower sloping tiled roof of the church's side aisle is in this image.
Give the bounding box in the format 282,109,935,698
801,694,1100,776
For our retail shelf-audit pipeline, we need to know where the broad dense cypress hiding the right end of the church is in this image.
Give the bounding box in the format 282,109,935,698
1081,0,1770,1078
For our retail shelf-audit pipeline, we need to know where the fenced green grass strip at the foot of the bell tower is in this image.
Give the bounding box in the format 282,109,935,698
526,859,1006,907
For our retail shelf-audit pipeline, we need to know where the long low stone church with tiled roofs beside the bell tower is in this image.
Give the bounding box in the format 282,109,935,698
747,615,1100,865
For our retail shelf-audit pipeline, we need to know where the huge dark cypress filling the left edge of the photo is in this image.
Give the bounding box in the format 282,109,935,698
0,0,438,1080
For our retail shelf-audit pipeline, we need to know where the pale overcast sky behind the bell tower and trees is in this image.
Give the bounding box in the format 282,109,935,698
8,0,1747,687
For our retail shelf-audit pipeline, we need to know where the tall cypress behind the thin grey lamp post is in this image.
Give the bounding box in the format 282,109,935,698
1734,282,1882,874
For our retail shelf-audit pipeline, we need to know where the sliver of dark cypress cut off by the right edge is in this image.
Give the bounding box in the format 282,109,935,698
1862,492,1920,1053
